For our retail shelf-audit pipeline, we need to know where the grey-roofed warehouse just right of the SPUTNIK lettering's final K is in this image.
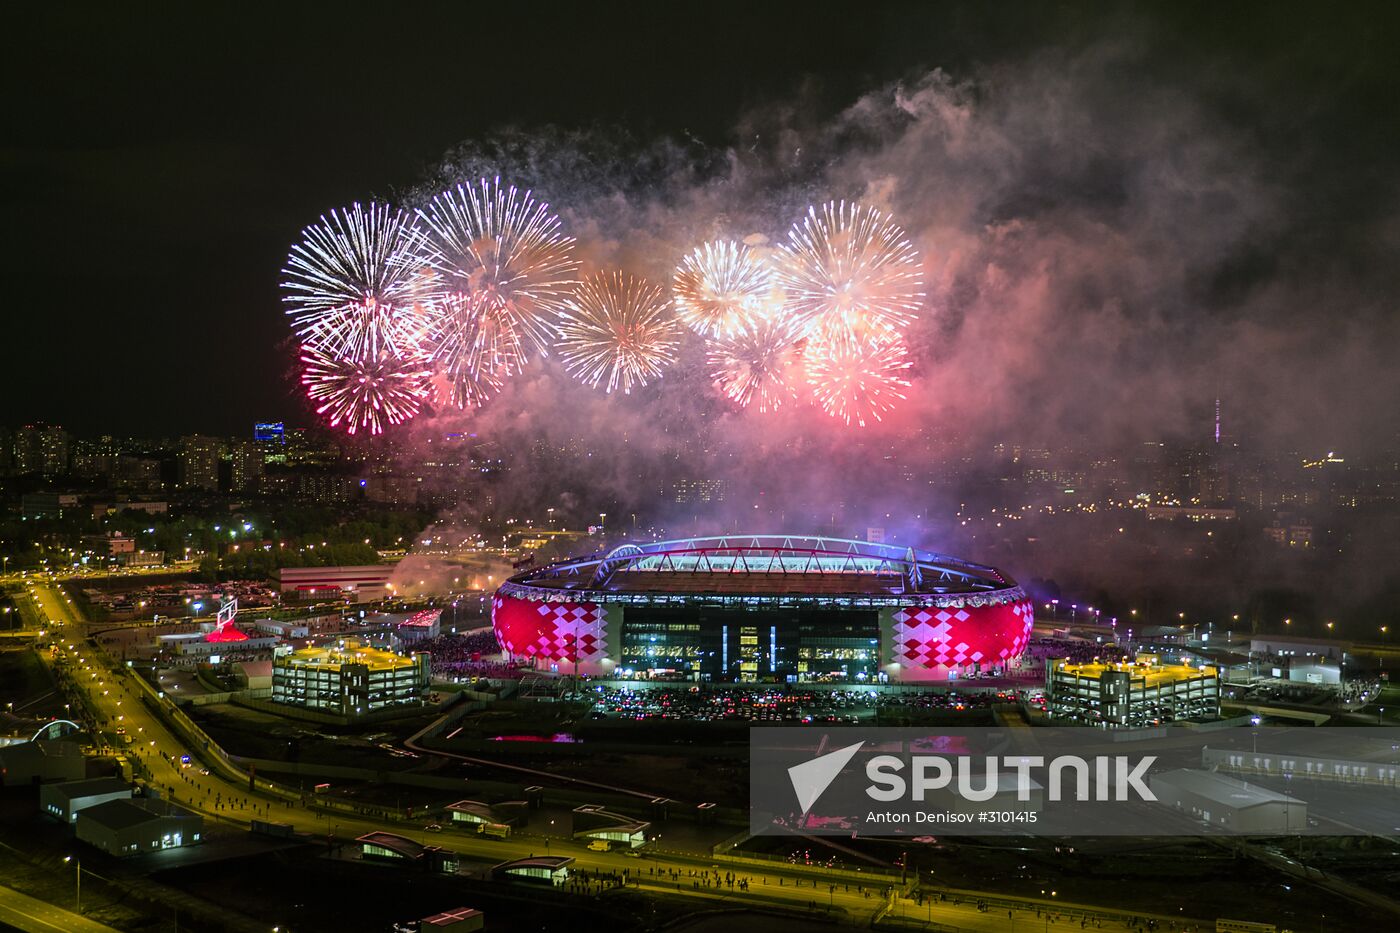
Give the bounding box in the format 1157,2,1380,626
1148,769,1308,835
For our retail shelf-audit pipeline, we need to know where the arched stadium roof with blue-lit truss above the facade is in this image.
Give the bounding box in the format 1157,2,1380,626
510,535,1019,597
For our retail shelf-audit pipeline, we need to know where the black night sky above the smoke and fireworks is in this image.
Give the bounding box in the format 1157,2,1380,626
10,1,1400,436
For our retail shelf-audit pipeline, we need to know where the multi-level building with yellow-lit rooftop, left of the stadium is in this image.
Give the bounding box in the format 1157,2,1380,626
272,639,431,717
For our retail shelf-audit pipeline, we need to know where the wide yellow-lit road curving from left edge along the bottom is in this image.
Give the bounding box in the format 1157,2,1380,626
32,584,1215,933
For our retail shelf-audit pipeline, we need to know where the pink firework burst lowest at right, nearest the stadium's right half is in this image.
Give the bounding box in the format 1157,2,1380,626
804,333,910,427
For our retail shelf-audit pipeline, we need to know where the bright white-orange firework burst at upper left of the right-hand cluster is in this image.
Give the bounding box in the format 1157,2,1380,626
672,240,773,338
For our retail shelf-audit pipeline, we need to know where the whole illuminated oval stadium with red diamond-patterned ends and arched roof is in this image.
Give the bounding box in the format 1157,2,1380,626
491,535,1033,684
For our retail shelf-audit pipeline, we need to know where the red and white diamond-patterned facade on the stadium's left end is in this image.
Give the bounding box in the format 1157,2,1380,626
491,593,608,665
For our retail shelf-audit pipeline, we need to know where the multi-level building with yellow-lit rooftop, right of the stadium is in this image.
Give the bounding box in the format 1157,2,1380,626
1046,654,1221,727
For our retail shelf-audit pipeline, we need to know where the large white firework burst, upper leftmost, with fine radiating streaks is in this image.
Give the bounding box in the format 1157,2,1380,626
281,202,430,359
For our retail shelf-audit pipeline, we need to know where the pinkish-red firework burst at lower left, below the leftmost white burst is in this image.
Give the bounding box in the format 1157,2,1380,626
301,345,431,434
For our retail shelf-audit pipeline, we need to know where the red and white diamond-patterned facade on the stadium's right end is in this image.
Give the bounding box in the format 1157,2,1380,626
889,600,1035,671
